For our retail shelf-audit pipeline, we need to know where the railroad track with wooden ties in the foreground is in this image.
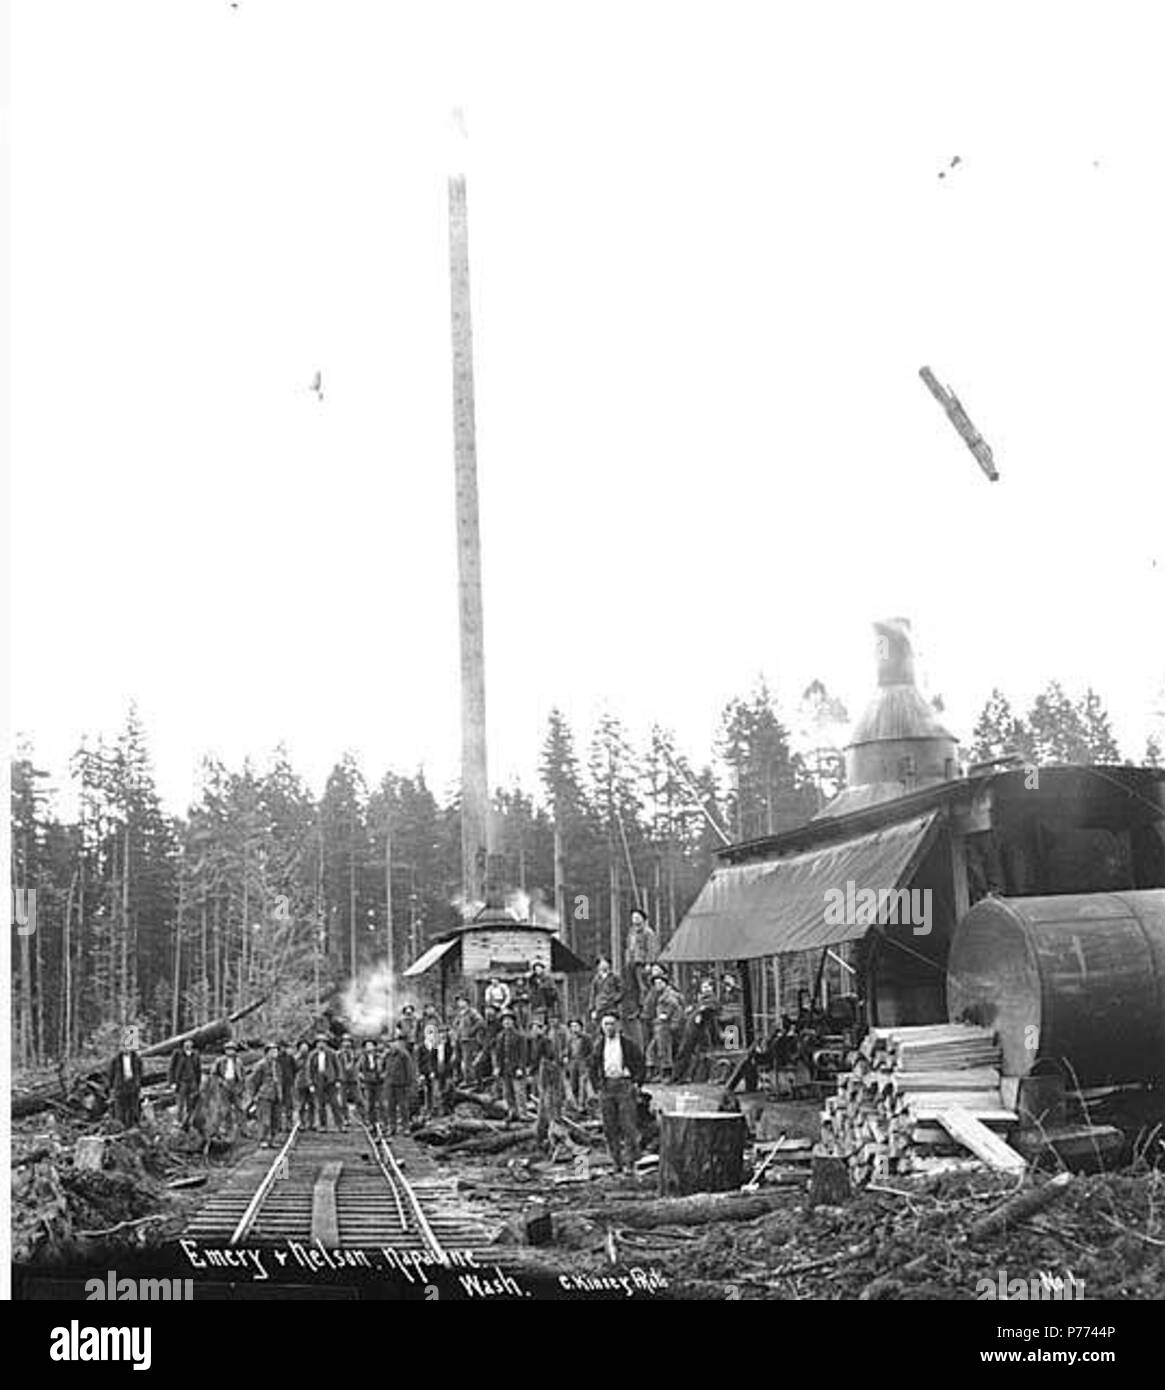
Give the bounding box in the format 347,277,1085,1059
184,1123,491,1261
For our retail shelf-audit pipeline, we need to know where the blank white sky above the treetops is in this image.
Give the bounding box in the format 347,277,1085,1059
13,0,1165,810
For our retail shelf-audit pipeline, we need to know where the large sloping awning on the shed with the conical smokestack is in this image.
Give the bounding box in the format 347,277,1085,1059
663,812,938,960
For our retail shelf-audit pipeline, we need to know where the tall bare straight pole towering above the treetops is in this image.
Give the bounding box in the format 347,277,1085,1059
449,113,491,904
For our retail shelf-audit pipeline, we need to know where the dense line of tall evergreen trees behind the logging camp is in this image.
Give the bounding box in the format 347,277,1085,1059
11,681,1151,1065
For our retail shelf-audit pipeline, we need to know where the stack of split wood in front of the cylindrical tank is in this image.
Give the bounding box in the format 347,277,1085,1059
817,1023,1022,1184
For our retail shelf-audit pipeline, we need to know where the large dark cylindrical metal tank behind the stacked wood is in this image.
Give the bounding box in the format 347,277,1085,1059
947,888,1165,1087
